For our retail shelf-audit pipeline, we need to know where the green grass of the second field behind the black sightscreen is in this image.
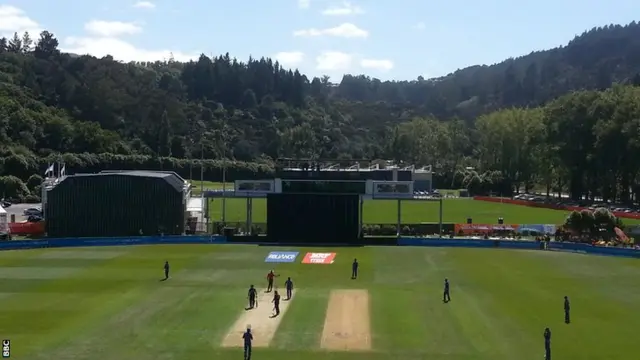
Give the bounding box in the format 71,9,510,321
209,198,640,224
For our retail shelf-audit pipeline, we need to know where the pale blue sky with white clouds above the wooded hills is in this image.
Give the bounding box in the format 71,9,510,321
0,0,640,82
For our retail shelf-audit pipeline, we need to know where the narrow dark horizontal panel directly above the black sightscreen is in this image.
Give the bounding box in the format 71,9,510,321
282,180,367,195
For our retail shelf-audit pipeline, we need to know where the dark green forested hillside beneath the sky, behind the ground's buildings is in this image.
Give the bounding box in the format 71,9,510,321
0,23,640,201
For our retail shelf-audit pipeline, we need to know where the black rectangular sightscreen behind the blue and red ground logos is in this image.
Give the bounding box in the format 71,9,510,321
267,194,360,243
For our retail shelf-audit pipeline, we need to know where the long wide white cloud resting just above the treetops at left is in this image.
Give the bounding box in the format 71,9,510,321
63,37,200,61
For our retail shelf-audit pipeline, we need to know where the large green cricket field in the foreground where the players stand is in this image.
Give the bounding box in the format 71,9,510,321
0,245,640,360
